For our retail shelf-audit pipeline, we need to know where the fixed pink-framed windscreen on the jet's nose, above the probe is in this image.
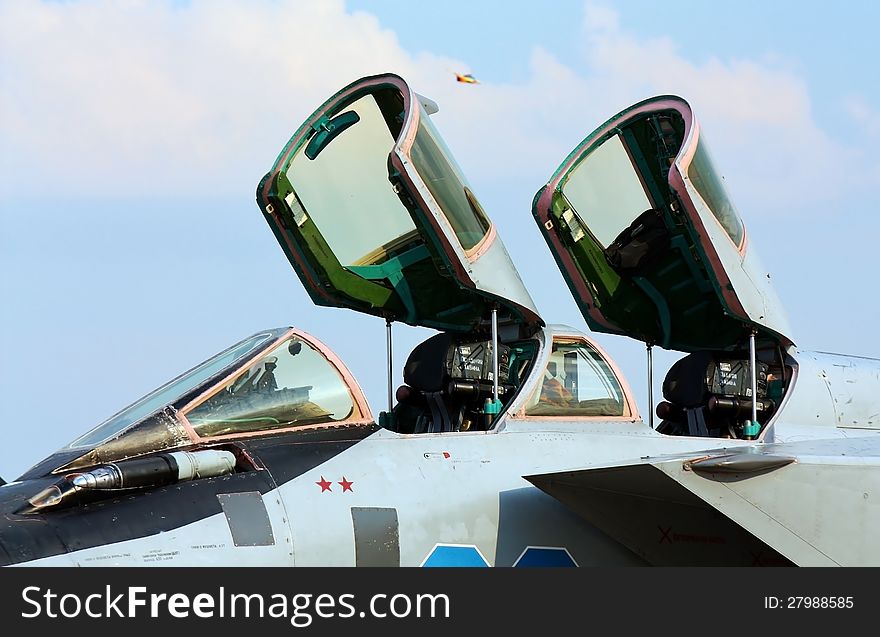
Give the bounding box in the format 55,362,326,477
42,328,372,470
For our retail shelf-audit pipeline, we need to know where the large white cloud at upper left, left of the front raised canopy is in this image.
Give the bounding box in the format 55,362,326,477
0,0,426,193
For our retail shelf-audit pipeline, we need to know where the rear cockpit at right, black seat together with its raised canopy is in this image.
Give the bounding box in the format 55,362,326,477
532,95,794,439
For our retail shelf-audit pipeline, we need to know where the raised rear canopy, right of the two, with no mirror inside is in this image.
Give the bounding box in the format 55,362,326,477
532,96,791,351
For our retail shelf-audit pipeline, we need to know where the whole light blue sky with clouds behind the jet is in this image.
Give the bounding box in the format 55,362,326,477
0,0,880,479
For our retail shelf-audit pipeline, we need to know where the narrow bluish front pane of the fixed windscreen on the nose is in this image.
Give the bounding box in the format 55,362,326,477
68,332,278,447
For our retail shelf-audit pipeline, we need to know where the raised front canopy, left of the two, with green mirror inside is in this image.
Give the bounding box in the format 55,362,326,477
257,75,542,331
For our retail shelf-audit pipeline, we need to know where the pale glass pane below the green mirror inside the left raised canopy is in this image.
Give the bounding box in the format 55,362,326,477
286,94,415,266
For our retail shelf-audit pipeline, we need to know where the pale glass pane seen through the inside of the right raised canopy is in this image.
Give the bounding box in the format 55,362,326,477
562,135,652,248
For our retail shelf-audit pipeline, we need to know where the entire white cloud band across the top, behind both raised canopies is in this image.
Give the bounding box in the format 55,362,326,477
0,0,876,212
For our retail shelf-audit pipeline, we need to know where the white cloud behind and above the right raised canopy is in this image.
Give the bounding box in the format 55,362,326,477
422,2,868,214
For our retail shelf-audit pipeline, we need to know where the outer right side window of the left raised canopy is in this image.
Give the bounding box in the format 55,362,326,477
411,104,491,250
